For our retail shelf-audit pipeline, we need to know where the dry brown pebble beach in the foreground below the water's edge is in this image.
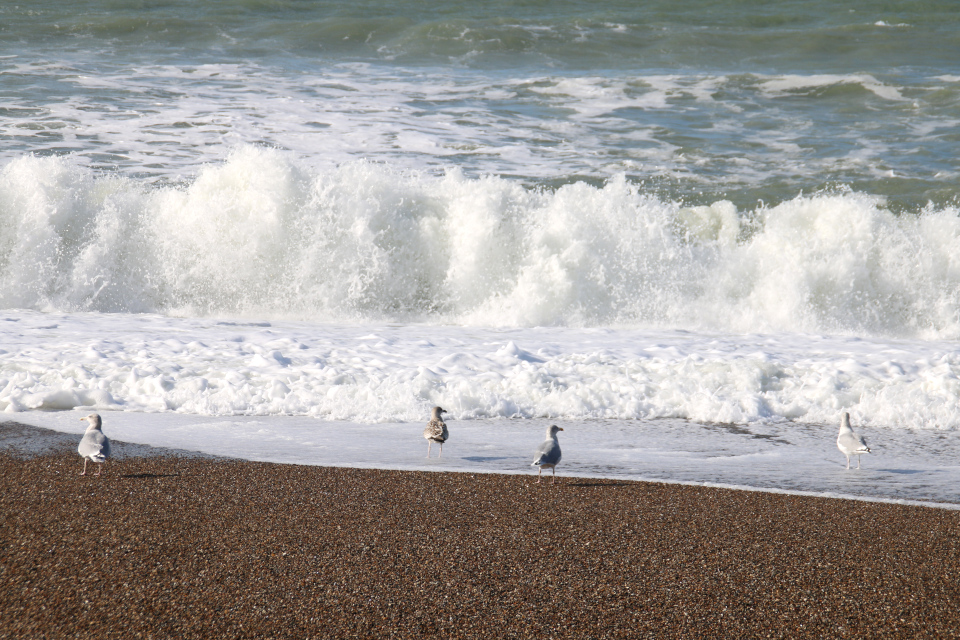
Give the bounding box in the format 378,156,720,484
0,422,960,638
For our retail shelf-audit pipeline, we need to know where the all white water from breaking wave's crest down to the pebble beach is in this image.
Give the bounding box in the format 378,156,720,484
0,147,960,503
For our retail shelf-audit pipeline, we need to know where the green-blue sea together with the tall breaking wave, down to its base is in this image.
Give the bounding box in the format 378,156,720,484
0,0,960,339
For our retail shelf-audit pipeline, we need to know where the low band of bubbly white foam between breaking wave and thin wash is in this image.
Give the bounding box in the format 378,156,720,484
0,311,960,430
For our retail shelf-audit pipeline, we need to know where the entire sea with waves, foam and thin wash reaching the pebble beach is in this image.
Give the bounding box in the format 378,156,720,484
0,0,960,501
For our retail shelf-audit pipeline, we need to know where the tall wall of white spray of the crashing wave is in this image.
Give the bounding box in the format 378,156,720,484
0,146,960,339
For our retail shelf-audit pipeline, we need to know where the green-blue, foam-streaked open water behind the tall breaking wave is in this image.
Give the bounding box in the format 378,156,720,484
0,1,960,210
